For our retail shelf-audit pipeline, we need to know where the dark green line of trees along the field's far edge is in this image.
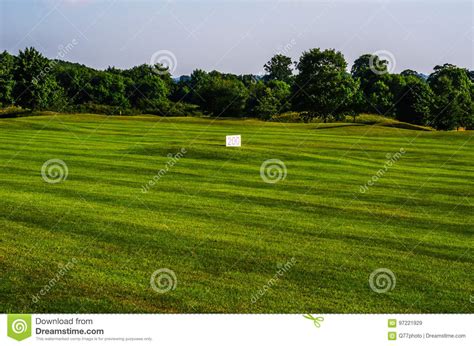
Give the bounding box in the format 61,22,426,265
0,48,474,130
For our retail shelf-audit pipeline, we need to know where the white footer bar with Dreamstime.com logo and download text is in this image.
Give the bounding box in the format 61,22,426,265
0,314,474,346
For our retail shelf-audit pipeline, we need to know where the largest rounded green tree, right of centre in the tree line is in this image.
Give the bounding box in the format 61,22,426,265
294,48,358,122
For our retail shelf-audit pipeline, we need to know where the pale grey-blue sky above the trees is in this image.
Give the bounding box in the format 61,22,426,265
0,0,473,76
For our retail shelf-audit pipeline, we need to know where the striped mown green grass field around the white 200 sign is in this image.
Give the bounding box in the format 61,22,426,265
0,115,474,313
